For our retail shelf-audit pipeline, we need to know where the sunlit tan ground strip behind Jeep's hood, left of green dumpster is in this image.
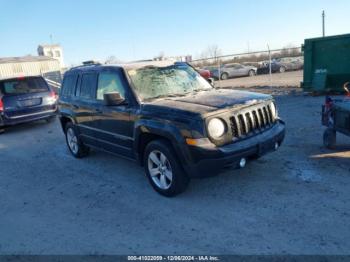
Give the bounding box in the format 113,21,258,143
216,71,303,87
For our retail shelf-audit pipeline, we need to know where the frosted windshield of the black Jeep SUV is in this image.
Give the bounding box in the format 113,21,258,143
127,64,213,101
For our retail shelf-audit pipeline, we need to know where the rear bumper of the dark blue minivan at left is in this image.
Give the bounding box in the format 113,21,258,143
0,107,57,127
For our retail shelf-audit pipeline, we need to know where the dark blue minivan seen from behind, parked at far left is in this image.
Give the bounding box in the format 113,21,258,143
0,76,57,132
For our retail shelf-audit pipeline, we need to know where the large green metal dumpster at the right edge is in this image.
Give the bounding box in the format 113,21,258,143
301,34,350,93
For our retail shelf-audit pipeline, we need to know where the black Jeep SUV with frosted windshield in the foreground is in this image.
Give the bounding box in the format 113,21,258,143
59,61,285,196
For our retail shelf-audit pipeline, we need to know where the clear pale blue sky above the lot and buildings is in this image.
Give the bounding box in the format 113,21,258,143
0,0,350,65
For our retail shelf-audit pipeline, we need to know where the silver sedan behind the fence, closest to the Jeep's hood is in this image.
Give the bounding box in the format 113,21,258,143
211,63,257,80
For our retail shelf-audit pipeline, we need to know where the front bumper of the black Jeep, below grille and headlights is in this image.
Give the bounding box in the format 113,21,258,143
185,120,285,178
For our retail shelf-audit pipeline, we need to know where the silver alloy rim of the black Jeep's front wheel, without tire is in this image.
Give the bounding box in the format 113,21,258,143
148,150,173,190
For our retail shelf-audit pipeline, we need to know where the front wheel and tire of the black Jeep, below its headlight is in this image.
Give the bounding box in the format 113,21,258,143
144,140,189,197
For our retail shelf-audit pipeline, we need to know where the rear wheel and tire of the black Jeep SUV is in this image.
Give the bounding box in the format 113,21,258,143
65,122,90,158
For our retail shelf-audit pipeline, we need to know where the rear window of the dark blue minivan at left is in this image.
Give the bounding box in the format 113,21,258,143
0,77,49,95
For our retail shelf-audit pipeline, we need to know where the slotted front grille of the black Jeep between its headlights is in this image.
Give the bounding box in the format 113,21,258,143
230,105,276,138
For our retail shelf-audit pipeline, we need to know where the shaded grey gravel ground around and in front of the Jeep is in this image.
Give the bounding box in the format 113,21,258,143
0,87,350,254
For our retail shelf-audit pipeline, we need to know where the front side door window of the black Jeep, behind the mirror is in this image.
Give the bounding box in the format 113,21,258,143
96,72,125,100
